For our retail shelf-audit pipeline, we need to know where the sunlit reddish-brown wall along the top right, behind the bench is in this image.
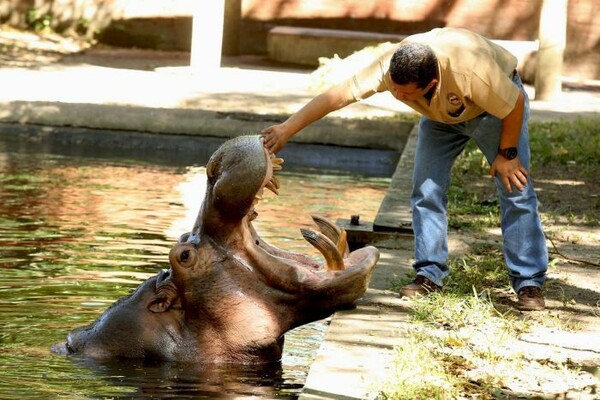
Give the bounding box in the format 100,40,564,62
242,0,600,79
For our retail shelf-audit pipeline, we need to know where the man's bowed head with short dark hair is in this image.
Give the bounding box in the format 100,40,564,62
390,42,438,101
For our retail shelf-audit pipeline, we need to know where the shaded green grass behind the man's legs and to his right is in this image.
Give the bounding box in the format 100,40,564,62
448,118,600,231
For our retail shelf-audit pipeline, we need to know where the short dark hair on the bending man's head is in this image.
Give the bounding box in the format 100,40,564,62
390,42,438,89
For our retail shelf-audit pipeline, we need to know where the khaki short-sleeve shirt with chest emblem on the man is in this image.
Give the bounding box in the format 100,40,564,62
344,28,519,124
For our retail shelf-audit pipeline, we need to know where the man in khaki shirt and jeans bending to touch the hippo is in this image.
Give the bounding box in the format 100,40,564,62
262,28,548,310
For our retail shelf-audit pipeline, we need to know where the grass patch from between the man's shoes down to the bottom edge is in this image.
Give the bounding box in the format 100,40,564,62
378,245,529,399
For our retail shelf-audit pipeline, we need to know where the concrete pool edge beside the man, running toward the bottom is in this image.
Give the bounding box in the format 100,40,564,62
300,126,417,400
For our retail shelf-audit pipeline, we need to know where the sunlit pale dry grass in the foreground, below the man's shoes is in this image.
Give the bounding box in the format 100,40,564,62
378,292,525,399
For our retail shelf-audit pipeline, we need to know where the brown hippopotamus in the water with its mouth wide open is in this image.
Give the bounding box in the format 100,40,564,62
55,135,379,364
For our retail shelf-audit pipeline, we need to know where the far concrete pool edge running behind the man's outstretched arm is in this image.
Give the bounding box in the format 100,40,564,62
0,101,414,151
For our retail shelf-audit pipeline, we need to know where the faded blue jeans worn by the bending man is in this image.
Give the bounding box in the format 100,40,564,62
411,74,548,292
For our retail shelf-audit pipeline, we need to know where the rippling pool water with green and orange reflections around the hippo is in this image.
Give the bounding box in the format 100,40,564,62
0,135,389,399
